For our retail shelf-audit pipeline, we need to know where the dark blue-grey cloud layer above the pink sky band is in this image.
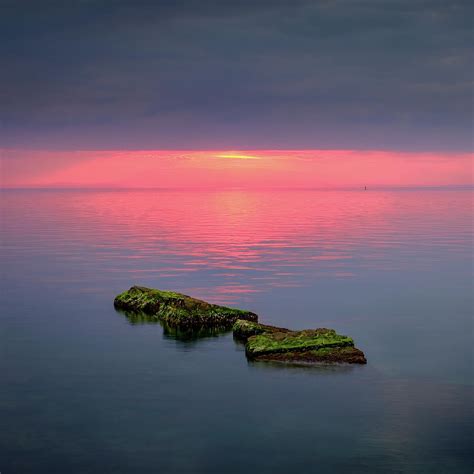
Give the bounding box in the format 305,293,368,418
0,0,473,150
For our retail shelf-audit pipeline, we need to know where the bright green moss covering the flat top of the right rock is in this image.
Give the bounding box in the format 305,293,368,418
246,328,354,357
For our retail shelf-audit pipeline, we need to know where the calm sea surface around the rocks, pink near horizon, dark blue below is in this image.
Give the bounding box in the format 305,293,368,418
0,190,474,474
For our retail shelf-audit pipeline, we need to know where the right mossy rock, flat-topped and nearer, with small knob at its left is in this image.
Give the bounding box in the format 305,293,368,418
232,320,367,364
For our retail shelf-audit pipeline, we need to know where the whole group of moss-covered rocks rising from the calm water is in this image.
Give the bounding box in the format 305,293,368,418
114,286,367,364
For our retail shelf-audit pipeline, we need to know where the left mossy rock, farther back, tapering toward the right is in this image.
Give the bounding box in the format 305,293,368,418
114,286,258,328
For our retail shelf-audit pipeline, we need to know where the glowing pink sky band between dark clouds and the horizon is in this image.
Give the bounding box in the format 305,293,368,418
0,149,473,189
